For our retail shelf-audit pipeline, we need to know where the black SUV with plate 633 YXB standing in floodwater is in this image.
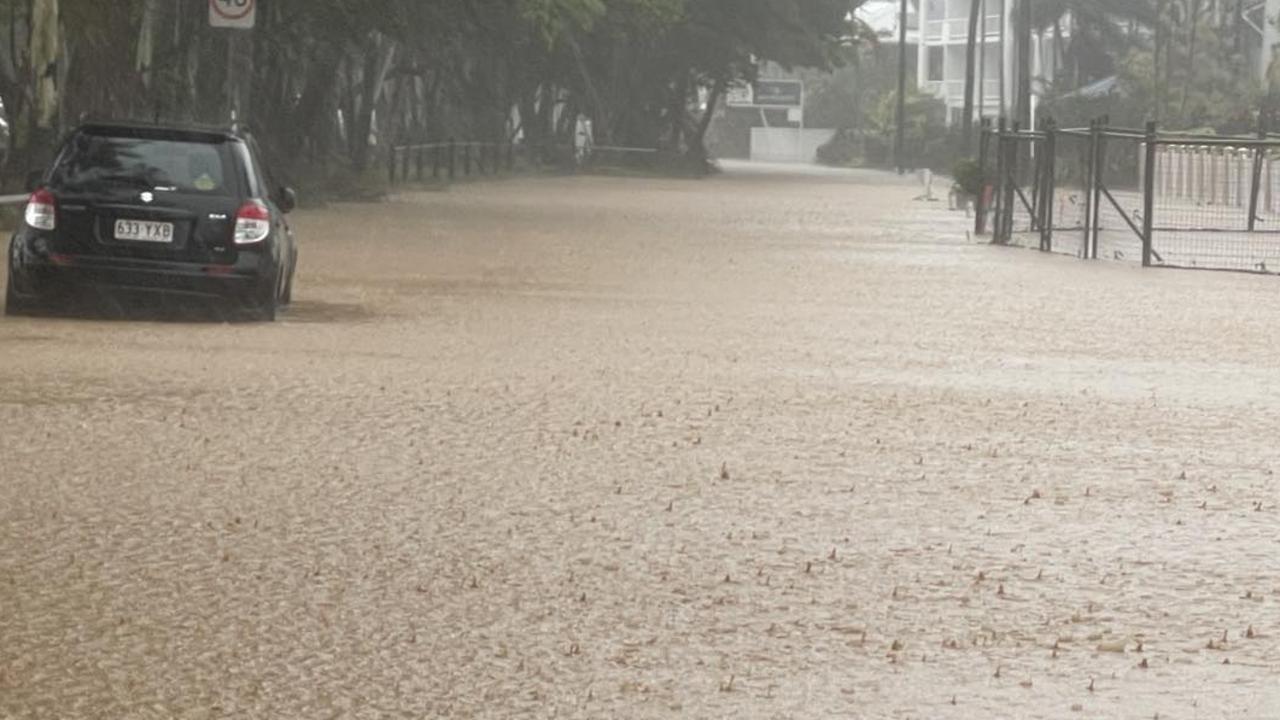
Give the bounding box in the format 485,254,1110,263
5,124,298,320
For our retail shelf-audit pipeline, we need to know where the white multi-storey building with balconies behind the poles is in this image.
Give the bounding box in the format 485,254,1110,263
916,0,1070,123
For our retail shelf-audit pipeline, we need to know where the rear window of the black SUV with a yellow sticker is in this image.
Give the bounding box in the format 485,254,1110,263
50,133,236,195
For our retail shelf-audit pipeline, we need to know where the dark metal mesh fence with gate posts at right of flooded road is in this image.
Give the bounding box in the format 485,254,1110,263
975,120,1280,273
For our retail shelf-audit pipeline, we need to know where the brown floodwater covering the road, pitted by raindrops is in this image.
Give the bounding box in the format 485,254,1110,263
0,168,1280,719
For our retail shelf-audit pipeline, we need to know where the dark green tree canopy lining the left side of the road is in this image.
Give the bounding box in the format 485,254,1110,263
0,0,861,178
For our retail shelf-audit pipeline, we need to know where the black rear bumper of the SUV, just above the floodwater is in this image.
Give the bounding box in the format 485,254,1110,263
9,236,274,297
